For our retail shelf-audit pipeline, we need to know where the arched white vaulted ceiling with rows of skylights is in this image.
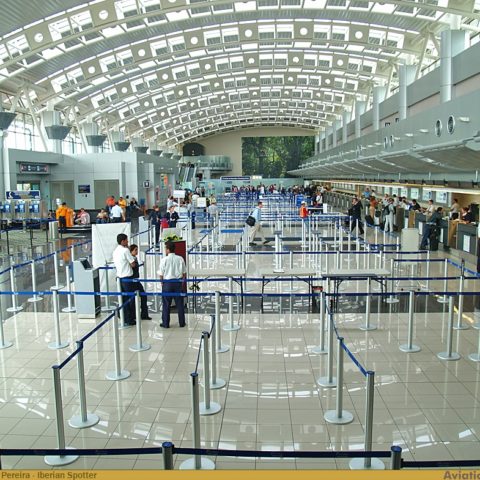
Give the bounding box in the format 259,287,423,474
0,0,480,145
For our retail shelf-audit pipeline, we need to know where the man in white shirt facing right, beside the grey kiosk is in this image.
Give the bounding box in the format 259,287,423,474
113,233,151,325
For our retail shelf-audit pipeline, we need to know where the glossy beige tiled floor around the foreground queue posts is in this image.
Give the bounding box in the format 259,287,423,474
0,225,480,469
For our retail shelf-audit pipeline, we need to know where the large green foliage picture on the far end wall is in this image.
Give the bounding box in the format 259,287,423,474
242,136,315,178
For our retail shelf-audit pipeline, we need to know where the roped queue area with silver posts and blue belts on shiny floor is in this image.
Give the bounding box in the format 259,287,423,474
0,191,480,469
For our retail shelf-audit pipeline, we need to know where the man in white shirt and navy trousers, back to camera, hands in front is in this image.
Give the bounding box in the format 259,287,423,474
158,242,187,328
